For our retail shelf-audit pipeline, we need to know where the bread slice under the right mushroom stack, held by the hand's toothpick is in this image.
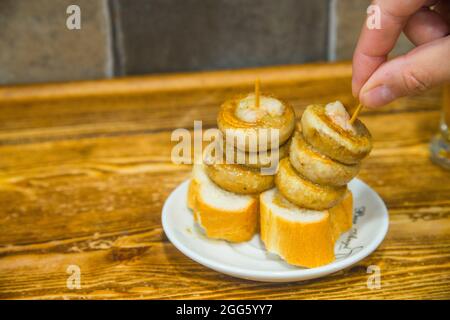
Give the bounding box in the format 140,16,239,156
260,188,352,268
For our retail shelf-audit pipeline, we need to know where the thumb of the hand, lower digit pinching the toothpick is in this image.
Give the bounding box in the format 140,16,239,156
359,36,450,108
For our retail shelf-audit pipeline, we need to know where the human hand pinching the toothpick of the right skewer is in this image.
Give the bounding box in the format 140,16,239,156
352,0,450,107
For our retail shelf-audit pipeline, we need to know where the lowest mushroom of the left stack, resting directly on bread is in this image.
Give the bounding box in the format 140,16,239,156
205,164,274,194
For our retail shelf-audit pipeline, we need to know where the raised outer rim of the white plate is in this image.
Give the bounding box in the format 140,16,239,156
161,178,389,282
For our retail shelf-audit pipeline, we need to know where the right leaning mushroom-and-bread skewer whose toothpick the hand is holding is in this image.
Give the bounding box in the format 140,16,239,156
261,101,372,267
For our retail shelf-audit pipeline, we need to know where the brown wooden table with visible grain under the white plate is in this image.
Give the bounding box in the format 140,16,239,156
0,63,450,299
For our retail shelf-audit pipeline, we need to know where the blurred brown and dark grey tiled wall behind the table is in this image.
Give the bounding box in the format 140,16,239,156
0,0,412,84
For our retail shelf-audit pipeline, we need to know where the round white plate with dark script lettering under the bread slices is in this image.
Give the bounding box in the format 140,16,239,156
162,179,389,282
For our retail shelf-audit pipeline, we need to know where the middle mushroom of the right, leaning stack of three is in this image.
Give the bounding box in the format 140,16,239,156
289,131,360,186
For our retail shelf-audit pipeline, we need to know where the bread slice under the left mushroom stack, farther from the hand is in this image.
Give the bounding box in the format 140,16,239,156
188,164,259,242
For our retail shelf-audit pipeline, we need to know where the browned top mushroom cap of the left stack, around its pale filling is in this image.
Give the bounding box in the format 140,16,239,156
217,97,295,151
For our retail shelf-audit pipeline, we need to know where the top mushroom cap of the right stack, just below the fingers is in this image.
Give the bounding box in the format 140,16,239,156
301,105,372,164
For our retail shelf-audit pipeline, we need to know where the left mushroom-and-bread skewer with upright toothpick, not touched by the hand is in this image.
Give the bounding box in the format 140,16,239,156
188,81,295,242
